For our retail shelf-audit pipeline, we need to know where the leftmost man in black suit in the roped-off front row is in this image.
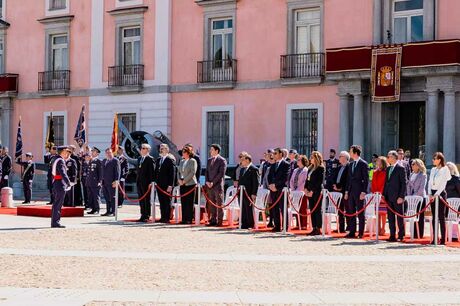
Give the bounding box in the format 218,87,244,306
136,143,155,222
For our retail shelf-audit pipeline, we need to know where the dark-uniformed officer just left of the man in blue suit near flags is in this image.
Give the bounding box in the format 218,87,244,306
86,147,102,215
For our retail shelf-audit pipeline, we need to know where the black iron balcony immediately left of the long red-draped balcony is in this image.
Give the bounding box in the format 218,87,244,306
280,53,325,85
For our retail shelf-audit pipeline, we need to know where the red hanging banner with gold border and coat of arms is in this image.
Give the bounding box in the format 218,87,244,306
371,46,402,102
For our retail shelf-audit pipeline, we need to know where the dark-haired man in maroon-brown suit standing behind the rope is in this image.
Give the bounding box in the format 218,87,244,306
205,144,227,226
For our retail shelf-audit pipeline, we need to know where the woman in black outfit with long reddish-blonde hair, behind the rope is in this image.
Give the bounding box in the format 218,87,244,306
305,151,326,236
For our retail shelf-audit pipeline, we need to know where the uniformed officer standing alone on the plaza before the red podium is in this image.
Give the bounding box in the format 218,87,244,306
51,146,71,228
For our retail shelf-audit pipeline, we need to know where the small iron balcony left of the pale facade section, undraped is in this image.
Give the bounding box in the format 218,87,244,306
38,70,70,96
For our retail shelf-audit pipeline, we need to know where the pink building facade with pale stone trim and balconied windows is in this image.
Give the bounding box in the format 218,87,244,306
0,0,460,172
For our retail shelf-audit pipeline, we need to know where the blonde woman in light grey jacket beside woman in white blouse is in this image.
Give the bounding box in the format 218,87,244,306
407,158,427,239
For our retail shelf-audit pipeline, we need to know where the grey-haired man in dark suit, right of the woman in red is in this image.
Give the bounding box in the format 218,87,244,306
383,151,407,242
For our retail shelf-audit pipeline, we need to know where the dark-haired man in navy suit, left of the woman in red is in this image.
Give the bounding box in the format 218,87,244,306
344,145,369,238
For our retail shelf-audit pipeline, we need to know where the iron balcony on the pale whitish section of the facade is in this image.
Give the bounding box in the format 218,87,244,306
108,65,144,93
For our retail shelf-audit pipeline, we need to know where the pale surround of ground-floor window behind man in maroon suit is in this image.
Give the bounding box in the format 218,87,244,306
200,105,235,165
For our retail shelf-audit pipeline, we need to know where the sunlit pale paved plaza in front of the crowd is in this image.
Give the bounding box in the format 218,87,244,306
0,205,460,306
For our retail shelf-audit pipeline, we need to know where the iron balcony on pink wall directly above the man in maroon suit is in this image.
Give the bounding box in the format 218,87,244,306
197,59,237,89
